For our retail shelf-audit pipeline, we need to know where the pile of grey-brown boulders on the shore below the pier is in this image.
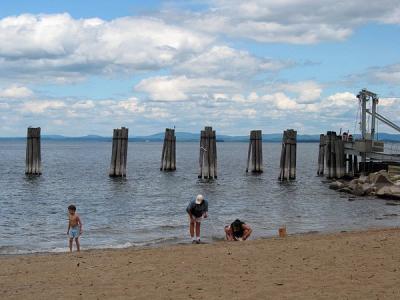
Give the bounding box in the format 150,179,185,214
329,170,400,200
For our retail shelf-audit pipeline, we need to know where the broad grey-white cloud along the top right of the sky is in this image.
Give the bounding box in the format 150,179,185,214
177,0,400,44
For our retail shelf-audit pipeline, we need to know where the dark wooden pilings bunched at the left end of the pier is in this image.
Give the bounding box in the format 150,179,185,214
317,131,359,178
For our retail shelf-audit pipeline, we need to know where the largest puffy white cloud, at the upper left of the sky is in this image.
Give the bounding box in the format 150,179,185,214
0,14,213,82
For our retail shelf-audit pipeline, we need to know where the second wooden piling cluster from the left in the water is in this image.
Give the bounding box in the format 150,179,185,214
109,127,128,177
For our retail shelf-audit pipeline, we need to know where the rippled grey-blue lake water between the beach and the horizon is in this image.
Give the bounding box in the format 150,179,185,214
0,141,400,254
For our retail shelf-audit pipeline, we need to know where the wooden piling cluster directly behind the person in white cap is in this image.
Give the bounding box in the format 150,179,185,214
198,127,217,179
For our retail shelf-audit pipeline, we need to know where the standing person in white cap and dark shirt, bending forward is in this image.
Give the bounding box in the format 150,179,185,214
186,195,208,244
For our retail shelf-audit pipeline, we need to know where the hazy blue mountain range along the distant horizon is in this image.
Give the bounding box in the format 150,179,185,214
0,132,400,143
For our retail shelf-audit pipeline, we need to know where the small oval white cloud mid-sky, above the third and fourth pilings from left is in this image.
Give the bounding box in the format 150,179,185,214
135,76,237,101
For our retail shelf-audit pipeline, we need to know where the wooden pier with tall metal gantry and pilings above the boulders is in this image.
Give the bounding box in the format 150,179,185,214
317,89,400,178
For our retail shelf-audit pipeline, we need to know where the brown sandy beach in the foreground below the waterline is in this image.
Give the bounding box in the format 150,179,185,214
0,229,400,300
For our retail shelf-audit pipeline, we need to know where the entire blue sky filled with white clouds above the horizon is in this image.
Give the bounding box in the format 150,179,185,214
0,0,400,137
